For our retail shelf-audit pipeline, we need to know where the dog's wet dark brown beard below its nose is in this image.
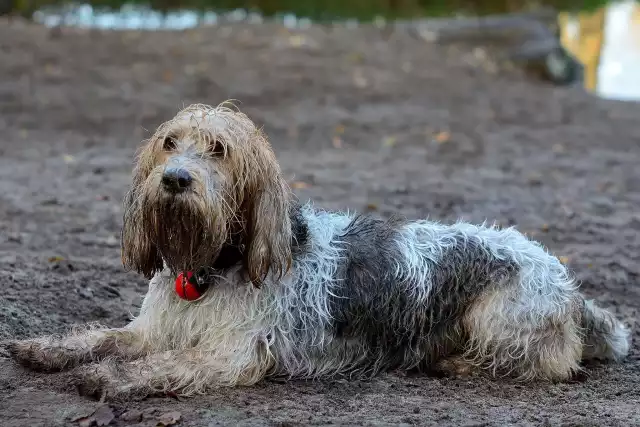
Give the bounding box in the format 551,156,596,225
141,190,232,273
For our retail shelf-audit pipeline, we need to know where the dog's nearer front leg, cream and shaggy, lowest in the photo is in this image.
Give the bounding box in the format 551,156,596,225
76,349,271,400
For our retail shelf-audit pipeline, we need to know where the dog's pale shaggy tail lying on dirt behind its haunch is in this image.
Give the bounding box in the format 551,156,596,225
582,300,631,362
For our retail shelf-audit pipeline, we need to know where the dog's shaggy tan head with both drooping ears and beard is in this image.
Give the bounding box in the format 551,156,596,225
122,105,291,285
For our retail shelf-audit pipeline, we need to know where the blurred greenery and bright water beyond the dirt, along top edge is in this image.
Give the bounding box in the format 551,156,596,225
0,0,640,99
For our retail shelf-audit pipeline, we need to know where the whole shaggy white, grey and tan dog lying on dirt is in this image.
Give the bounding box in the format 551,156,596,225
10,103,630,399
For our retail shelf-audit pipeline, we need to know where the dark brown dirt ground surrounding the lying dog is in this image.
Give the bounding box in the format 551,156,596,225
0,16,640,427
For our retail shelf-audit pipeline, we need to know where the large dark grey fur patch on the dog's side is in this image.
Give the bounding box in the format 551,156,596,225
329,216,519,374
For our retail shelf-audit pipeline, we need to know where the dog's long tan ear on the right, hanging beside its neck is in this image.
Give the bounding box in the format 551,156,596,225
242,150,292,287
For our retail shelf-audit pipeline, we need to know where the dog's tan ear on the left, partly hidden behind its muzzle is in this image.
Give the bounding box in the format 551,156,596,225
120,163,163,279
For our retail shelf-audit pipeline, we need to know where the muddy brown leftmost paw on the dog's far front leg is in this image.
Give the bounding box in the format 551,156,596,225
7,338,81,372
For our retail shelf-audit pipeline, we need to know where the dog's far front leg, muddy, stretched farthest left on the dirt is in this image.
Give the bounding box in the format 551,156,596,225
8,327,144,372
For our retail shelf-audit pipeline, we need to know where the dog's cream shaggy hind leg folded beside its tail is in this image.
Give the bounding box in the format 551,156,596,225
464,291,582,381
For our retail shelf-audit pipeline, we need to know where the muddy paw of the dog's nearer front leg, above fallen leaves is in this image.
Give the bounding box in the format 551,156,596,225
73,362,150,402
